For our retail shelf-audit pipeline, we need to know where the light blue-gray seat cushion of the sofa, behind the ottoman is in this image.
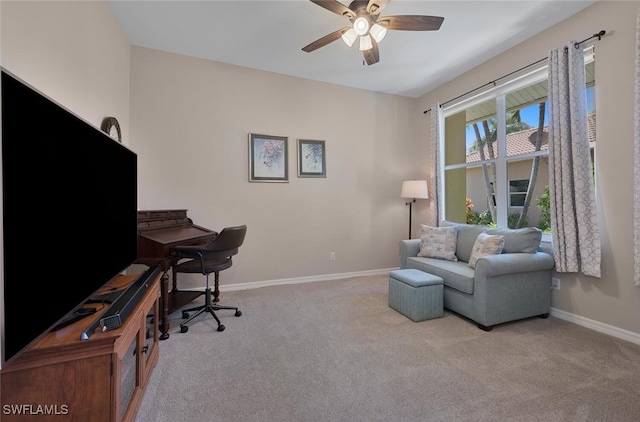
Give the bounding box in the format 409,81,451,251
406,256,474,294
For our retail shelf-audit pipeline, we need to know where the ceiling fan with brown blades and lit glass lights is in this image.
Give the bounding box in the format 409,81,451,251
302,0,444,65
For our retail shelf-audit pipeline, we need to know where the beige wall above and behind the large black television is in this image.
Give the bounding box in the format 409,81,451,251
0,0,130,366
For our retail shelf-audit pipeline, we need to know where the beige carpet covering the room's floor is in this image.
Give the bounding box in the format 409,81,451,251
137,276,640,422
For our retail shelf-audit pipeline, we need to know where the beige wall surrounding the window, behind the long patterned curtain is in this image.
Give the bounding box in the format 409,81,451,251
419,0,640,341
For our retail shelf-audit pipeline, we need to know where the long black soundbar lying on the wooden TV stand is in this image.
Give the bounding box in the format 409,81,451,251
80,265,160,340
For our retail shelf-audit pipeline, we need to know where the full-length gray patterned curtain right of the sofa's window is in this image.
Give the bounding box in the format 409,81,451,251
549,42,601,277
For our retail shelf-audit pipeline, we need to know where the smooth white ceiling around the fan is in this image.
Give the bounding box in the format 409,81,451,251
110,0,597,98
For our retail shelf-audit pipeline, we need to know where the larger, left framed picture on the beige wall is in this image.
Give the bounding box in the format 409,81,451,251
249,133,289,182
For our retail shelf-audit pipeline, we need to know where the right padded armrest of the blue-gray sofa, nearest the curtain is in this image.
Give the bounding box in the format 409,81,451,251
475,252,554,279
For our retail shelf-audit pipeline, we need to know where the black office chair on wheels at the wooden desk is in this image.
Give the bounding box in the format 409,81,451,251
175,225,247,333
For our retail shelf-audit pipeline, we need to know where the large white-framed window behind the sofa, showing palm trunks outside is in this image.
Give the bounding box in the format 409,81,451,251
441,53,595,233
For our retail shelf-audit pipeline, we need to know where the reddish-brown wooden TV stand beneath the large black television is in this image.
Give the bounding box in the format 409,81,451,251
0,274,161,422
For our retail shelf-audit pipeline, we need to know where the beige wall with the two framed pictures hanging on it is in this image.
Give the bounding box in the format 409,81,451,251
131,47,426,286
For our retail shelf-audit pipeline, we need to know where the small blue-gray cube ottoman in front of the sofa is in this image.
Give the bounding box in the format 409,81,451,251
389,268,444,322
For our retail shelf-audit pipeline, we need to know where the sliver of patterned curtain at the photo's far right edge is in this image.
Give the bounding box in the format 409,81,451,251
633,10,640,287
